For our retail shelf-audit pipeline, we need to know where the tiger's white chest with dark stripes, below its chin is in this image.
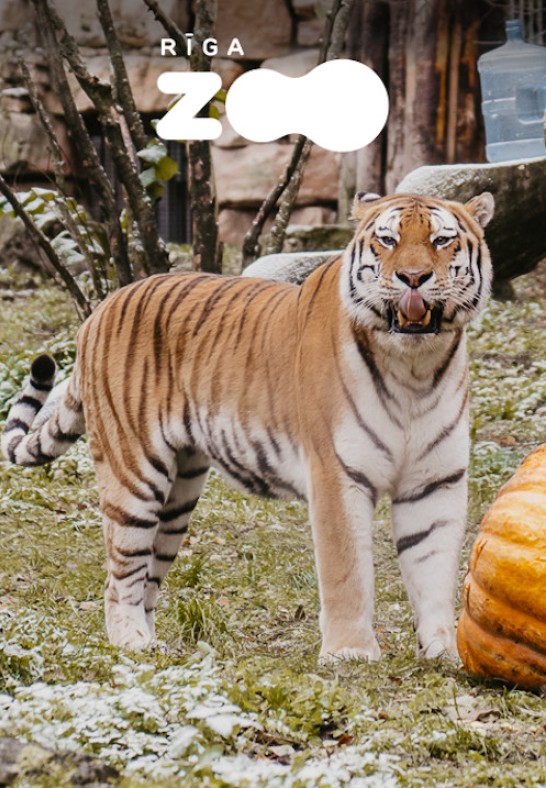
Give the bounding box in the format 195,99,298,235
335,336,469,498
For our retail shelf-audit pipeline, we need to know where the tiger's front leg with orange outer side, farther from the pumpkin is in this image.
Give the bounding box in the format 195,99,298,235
309,456,380,661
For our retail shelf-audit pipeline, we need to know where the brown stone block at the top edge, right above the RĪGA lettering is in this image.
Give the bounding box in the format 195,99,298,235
215,0,292,60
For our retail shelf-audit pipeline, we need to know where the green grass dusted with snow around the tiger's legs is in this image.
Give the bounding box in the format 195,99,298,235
0,270,546,788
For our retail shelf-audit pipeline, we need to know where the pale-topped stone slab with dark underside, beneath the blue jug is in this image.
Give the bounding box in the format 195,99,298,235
396,158,546,282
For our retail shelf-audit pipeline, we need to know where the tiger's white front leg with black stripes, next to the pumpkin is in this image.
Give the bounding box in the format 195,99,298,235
392,467,467,658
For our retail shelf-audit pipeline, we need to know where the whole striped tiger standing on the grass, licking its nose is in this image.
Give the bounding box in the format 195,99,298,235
2,192,494,661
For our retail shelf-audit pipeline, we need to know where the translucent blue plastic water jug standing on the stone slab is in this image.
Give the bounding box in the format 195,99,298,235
478,20,546,162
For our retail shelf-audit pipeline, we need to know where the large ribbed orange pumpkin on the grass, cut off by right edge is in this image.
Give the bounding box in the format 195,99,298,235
457,444,546,689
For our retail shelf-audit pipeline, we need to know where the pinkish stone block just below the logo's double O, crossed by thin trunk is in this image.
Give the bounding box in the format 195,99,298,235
212,142,339,208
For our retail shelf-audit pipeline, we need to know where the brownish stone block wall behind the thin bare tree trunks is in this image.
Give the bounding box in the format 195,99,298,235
0,0,340,244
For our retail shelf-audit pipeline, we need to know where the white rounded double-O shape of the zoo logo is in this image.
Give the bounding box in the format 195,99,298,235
226,59,389,153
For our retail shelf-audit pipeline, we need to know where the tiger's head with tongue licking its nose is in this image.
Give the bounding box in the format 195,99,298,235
342,192,494,337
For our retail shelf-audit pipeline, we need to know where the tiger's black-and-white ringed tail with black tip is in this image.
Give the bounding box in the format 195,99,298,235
2,355,85,466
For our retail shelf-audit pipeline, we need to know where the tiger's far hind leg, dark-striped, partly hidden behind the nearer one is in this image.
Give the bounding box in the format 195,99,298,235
144,448,209,637
